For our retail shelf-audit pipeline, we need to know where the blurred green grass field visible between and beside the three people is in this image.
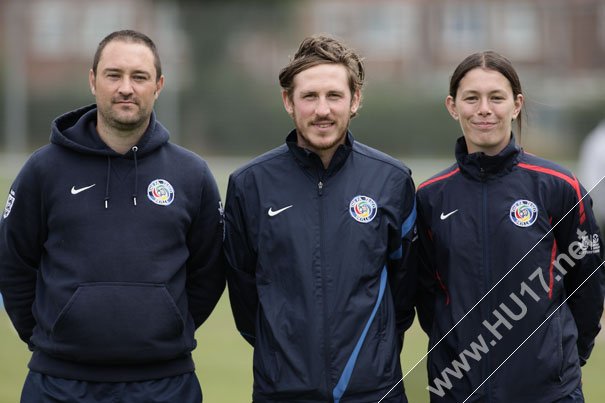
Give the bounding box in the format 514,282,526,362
0,155,605,403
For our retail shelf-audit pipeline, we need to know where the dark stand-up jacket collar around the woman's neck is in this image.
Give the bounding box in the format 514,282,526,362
456,133,523,180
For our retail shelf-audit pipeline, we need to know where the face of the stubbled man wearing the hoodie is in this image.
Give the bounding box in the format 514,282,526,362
89,40,164,133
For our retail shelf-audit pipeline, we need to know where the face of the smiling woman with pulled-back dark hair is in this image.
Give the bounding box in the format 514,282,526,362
445,67,523,155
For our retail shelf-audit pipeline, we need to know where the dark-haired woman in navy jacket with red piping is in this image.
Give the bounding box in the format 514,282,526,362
417,51,603,403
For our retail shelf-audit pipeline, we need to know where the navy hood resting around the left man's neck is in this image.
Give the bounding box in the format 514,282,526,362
50,104,169,159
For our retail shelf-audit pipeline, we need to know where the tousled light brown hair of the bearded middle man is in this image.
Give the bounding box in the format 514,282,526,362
279,35,365,117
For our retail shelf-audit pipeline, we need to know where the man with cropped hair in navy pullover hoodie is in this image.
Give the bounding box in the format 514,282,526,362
0,30,225,403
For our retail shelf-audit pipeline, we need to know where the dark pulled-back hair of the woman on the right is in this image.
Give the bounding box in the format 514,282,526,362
449,50,523,136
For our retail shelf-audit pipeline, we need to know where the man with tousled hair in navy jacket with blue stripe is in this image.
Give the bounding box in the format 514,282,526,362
225,37,415,403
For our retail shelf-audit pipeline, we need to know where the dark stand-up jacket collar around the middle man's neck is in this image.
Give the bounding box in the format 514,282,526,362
286,129,355,177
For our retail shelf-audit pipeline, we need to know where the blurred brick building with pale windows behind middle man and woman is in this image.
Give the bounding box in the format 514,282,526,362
231,0,605,83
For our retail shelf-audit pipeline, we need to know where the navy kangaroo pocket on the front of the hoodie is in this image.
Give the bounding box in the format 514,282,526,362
51,283,190,364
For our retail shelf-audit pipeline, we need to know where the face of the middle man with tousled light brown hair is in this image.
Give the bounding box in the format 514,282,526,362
282,64,360,156
